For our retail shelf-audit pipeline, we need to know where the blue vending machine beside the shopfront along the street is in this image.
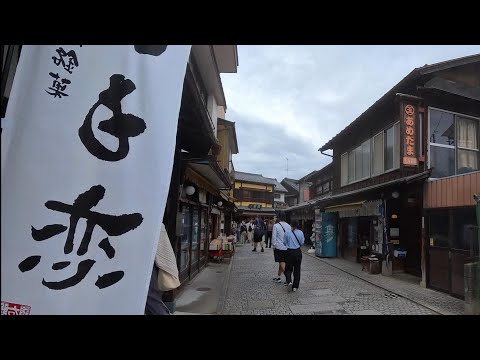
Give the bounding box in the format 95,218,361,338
315,212,337,257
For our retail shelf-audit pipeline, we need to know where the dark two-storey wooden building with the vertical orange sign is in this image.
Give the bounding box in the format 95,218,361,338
319,55,480,297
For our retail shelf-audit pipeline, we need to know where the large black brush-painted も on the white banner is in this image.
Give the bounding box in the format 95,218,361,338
78,74,147,161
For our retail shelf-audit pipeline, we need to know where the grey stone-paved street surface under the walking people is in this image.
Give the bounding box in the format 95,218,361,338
222,244,462,315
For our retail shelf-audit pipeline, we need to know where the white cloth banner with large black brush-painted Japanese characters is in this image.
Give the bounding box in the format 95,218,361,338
1,45,191,315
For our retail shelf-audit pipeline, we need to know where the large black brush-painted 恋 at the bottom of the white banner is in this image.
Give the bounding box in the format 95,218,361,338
18,185,143,290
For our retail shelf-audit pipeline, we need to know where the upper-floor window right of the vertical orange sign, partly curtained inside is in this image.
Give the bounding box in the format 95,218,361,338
429,108,479,178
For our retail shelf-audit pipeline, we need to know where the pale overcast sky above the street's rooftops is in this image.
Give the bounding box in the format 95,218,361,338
221,45,480,181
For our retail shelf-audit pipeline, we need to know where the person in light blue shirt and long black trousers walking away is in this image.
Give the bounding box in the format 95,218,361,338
283,220,305,292
